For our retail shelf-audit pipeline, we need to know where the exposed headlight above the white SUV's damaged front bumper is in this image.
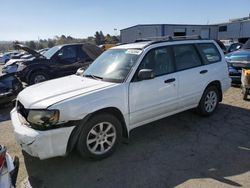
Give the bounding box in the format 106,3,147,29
27,110,59,128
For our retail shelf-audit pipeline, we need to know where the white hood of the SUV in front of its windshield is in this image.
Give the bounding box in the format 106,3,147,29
17,75,117,109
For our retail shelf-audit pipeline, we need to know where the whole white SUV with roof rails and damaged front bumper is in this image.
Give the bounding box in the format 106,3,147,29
11,39,231,159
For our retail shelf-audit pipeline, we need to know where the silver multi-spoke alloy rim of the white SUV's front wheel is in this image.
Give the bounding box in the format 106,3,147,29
87,122,116,155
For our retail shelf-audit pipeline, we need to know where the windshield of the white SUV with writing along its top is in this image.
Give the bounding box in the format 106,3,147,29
83,49,142,83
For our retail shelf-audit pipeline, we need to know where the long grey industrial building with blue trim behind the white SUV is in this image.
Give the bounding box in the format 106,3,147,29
121,15,250,43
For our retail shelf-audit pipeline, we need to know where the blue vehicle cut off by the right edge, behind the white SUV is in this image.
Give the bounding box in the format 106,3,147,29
225,40,250,84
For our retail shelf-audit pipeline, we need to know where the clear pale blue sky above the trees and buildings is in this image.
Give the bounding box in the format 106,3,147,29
0,0,250,41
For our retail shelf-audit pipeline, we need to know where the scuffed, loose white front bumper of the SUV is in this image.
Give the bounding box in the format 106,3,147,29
11,108,75,159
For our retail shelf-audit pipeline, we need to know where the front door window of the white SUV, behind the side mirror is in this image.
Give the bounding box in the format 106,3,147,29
139,47,174,76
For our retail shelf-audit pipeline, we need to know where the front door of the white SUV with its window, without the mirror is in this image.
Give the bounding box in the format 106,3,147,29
129,47,178,126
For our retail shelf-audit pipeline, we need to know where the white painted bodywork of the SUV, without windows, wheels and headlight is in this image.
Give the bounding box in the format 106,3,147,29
11,40,231,159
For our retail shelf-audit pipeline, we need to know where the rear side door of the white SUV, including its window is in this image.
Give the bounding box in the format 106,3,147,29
173,44,209,110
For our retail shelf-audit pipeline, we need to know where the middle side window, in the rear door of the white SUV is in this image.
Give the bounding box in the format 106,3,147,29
173,45,202,70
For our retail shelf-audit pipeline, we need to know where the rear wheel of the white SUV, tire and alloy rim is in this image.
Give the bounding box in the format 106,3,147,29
196,86,219,116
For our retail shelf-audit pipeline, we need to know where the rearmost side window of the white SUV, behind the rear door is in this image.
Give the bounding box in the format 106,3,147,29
198,43,221,63
